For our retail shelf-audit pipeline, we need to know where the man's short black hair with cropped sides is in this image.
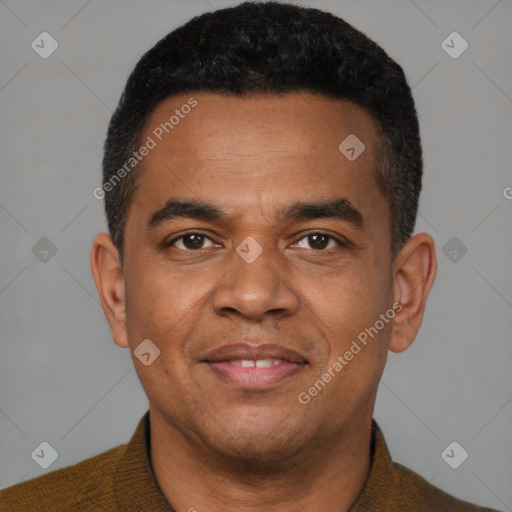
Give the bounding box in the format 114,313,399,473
103,1,423,261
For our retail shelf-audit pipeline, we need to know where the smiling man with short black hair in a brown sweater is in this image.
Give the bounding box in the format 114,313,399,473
0,2,498,512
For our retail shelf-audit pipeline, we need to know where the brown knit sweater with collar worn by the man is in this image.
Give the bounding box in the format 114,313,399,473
0,412,491,512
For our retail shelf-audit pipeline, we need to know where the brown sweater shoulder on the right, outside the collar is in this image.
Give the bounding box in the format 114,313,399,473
393,462,496,512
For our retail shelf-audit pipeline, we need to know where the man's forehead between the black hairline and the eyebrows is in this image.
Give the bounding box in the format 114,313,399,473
129,93,388,228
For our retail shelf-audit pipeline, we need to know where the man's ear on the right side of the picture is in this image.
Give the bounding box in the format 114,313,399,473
389,233,437,352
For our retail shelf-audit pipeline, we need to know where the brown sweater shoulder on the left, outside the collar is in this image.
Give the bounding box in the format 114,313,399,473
0,445,126,512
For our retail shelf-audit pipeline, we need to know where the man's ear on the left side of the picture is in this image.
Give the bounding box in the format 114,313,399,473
91,233,128,347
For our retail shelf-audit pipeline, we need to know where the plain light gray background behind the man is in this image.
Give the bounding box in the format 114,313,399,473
0,0,512,510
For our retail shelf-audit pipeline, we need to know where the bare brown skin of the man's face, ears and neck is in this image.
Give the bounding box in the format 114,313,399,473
91,93,436,512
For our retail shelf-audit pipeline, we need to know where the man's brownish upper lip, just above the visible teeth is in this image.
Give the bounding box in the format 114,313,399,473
203,343,307,363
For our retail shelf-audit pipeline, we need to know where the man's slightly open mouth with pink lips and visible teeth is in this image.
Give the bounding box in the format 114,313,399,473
202,343,308,390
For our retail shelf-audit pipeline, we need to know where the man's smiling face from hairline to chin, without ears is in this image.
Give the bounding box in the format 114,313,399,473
93,93,436,461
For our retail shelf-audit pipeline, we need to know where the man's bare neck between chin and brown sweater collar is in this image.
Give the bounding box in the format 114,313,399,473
150,409,371,512
